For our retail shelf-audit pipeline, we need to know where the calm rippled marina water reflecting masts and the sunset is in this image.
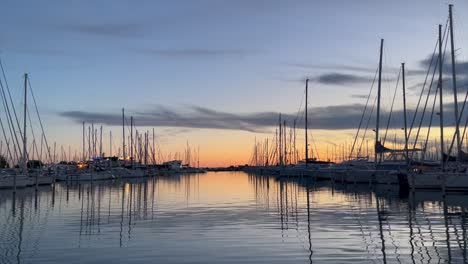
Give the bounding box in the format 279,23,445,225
0,172,468,263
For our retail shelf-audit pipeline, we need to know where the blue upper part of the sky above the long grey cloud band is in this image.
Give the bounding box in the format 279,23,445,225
0,0,468,165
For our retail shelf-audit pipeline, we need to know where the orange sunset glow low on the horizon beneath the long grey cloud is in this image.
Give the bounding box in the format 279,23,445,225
48,127,460,167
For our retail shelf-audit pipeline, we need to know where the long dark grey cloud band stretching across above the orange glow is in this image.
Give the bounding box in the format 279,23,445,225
59,104,464,132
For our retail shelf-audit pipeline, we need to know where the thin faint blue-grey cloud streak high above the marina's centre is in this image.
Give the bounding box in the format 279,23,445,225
142,49,259,58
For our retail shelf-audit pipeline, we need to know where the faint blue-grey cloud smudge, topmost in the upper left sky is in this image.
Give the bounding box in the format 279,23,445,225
61,23,144,37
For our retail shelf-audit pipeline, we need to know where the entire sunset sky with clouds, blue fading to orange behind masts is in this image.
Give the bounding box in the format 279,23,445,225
0,0,468,166
